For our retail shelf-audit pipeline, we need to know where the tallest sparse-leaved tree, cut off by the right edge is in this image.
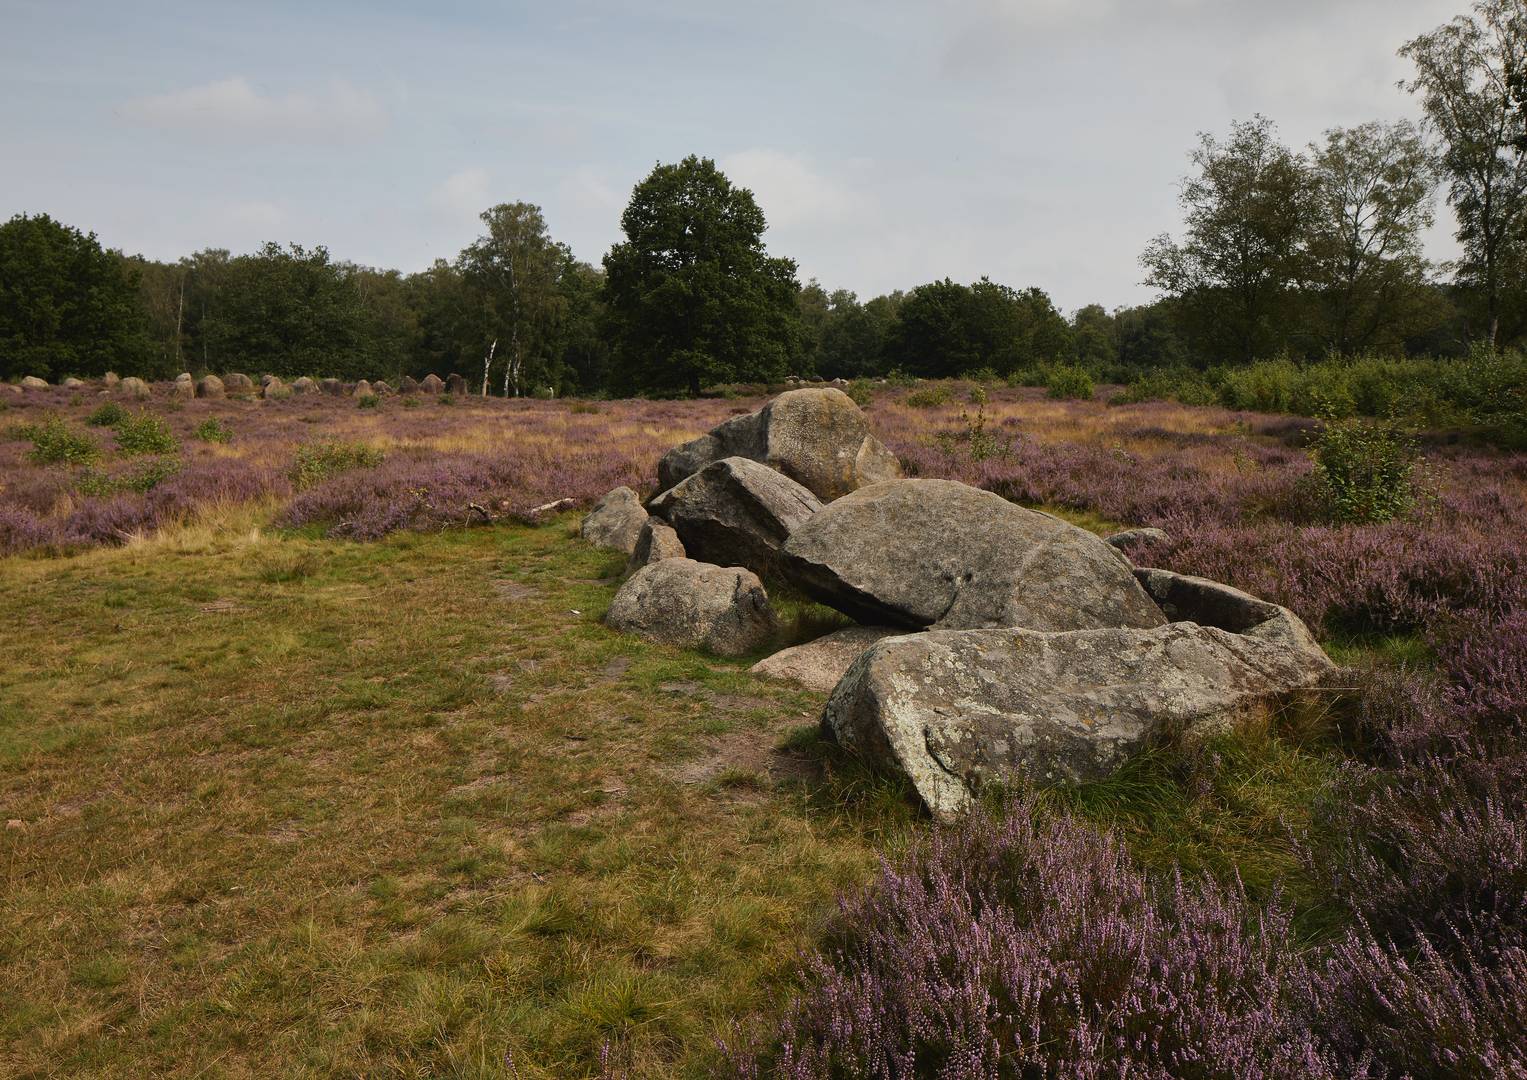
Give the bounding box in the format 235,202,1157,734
1400,0,1527,345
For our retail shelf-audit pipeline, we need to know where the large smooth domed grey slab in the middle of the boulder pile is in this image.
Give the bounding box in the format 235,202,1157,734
781,480,1165,631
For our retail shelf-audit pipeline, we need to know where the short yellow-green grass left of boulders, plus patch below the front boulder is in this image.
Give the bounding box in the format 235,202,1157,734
0,509,1349,1077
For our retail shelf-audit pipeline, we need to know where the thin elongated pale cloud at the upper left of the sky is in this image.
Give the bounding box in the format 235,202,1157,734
121,78,388,141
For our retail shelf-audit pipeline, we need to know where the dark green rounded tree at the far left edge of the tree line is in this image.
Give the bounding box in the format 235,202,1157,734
0,214,150,380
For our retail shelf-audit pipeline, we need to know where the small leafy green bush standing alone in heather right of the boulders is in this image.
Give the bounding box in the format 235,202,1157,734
1310,420,1420,524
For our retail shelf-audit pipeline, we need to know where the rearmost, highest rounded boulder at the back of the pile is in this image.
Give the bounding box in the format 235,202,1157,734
658,386,901,503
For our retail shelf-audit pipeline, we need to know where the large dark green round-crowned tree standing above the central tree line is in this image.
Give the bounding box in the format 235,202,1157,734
605,156,802,394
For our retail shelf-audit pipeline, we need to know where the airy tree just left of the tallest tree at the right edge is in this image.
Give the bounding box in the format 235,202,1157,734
1310,121,1435,353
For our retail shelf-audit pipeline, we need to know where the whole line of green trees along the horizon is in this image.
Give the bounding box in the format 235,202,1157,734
0,0,1527,396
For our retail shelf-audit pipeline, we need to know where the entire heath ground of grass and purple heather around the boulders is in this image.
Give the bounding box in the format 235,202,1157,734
0,382,1527,1077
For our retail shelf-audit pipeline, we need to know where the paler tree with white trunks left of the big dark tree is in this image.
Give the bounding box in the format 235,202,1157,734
461,203,567,397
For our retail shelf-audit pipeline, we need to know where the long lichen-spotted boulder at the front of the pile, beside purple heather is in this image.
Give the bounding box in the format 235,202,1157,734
822,622,1330,817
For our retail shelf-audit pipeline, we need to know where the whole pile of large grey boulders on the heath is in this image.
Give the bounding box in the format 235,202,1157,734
582,386,1332,816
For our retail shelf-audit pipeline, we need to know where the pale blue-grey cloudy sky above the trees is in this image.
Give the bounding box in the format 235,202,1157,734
0,0,1466,310
